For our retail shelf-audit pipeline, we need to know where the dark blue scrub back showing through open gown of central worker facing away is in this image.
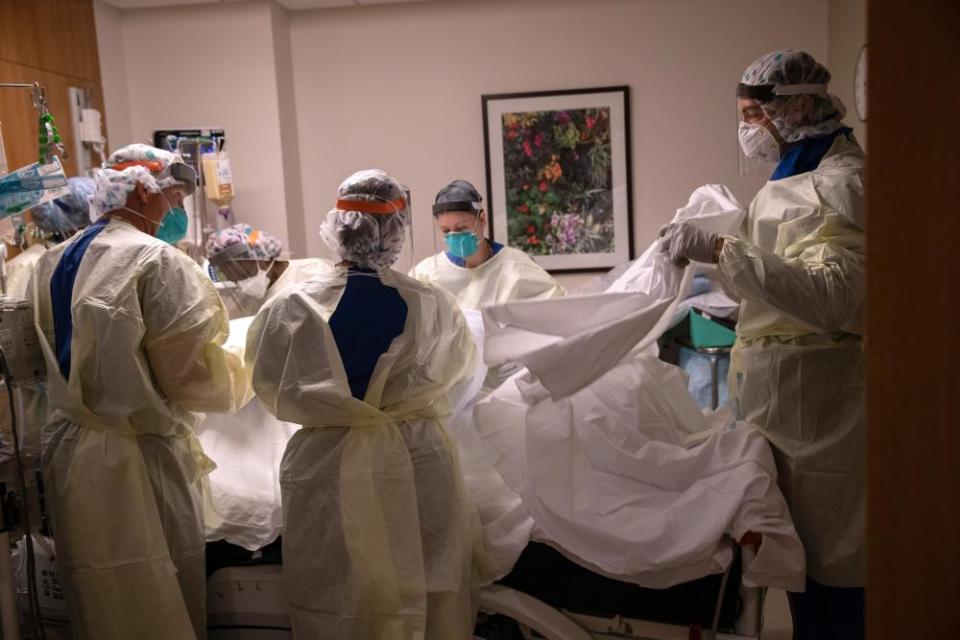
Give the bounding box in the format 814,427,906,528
330,270,407,400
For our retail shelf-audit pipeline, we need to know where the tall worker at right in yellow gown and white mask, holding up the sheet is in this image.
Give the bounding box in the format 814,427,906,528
661,50,866,640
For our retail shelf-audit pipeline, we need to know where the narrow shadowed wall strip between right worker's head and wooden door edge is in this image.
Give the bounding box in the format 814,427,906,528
827,0,867,148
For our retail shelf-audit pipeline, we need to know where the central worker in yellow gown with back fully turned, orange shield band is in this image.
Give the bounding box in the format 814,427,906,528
247,170,482,640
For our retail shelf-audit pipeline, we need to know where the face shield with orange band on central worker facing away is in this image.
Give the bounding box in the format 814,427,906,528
321,190,415,276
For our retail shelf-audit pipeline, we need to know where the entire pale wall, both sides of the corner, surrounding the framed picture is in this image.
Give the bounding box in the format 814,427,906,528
95,0,848,280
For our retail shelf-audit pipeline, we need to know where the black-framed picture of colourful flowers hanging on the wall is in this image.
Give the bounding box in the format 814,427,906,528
481,86,635,273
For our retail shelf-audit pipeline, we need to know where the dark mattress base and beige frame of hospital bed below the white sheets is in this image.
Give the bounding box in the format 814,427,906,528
207,541,763,640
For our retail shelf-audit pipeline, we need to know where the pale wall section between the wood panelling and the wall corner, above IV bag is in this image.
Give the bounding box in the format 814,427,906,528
97,1,305,250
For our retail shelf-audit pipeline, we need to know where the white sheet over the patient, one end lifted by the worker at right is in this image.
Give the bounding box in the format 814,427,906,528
451,186,804,590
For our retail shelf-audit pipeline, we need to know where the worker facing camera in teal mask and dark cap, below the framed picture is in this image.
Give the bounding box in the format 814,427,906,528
411,180,564,309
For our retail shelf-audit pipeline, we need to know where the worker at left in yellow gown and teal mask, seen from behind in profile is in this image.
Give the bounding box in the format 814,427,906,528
30,144,247,640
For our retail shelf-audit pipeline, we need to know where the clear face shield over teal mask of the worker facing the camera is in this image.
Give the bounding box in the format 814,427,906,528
433,201,489,268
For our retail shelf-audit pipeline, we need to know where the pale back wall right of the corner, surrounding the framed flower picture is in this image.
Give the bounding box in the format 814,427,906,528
290,0,828,280
